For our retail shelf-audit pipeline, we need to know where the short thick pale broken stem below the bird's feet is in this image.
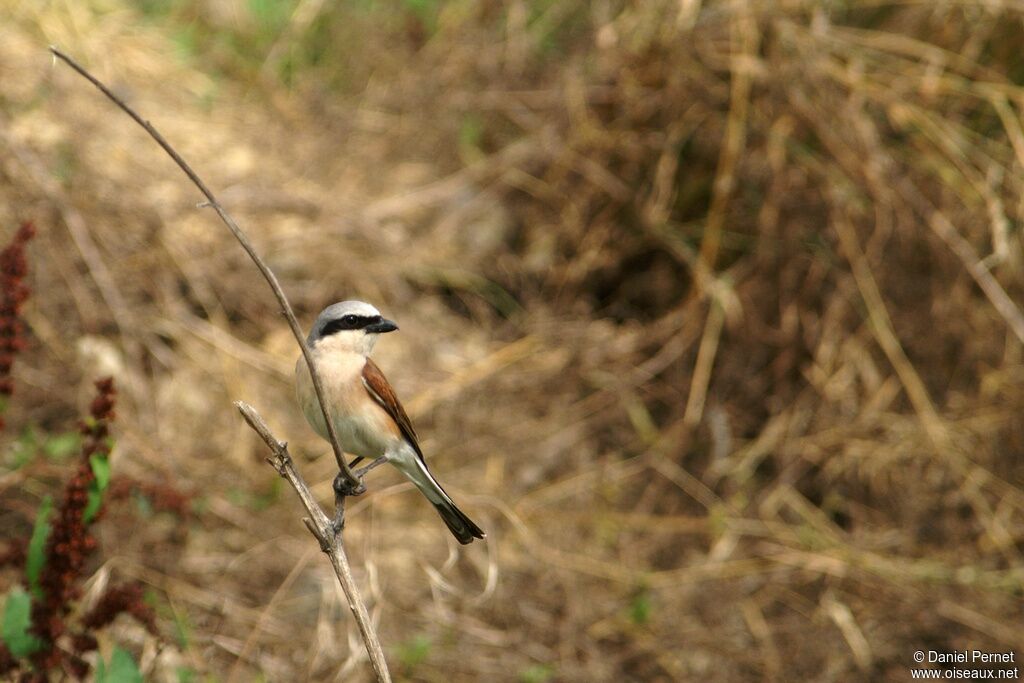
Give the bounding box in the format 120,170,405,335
234,401,391,681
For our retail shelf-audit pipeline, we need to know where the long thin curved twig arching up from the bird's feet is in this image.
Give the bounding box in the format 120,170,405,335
50,45,366,496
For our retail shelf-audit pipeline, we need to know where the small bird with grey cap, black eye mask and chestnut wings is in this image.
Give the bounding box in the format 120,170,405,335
295,301,486,545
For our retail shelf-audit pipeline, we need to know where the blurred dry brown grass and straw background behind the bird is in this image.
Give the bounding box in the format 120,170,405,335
0,0,1024,683
